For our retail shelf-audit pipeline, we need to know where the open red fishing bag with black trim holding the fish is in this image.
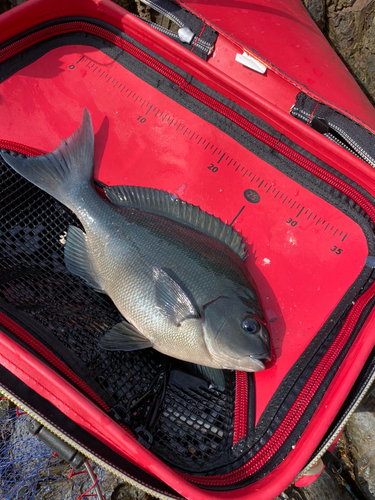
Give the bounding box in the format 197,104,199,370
0,0,375,500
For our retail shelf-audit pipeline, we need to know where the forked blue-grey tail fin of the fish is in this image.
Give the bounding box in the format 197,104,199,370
1,108,94,206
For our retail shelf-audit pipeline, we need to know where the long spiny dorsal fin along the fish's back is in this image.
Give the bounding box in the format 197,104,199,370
102,185,246,260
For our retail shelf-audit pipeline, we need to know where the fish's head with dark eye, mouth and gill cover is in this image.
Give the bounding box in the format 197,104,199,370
203,296,271,372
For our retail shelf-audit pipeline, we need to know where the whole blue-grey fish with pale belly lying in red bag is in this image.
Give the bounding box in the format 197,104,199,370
1,108,271,372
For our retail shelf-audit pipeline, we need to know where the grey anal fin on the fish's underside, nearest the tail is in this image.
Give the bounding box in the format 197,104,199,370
64,226,106,293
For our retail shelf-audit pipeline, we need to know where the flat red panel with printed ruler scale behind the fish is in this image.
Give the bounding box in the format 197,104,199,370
0,45,368,420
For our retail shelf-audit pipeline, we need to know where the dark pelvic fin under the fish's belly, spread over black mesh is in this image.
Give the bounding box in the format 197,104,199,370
99,321,152,351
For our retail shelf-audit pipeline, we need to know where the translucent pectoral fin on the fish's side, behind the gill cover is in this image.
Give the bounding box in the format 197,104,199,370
153,267,201,326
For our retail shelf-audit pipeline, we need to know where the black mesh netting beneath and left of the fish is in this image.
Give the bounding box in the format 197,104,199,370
0,154,234,472
